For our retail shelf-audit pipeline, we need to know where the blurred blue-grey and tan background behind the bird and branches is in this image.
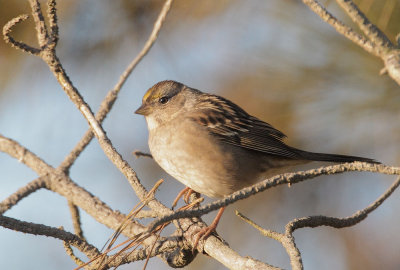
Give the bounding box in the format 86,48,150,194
0,0,400,269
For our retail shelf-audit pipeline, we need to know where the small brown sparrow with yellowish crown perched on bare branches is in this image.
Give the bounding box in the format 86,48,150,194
135,80,379,249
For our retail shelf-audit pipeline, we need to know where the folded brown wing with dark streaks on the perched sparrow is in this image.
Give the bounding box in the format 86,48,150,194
192,95,299,158
